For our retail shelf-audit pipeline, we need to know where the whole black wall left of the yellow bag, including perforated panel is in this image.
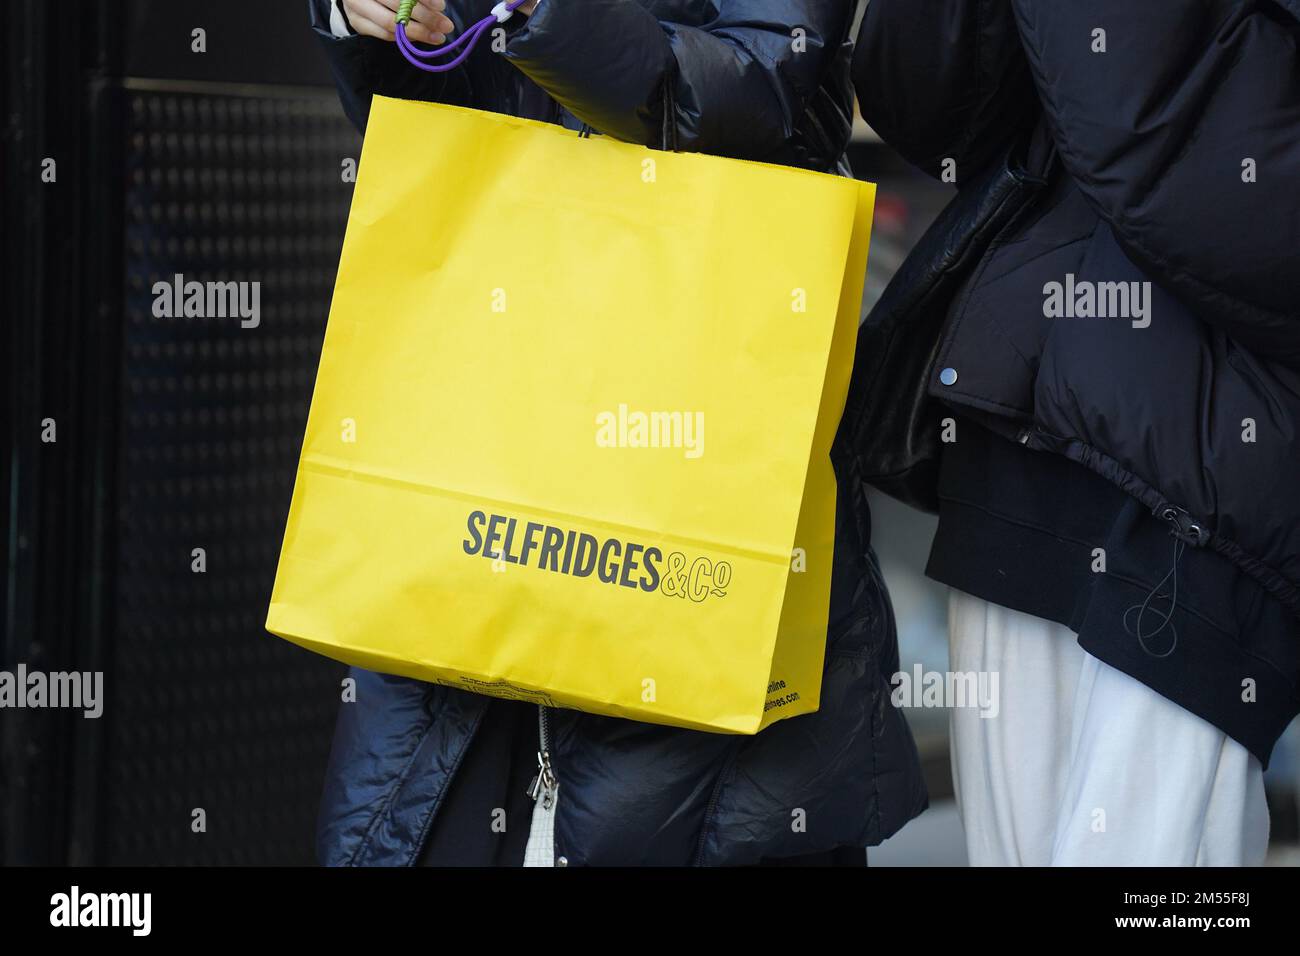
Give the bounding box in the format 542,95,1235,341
0,0,359,864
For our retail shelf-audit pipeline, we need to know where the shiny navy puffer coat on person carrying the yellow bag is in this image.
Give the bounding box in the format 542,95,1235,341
313,0,926,865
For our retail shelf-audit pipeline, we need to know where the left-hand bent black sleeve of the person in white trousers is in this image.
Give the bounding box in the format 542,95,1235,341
853,0,1040,180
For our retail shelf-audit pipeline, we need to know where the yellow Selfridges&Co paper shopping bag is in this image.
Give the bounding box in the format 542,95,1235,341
267,98,875,734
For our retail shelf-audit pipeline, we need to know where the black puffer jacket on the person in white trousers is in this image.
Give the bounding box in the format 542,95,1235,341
854,0,1300,761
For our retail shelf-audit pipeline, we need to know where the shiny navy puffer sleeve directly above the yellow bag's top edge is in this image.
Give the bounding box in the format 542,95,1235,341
506,0,853,159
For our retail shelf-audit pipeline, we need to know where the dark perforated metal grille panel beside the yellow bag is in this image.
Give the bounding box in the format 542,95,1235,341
101,87,360,864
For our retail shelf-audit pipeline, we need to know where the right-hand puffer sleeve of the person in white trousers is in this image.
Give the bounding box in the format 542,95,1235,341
1013,0,1300,367
